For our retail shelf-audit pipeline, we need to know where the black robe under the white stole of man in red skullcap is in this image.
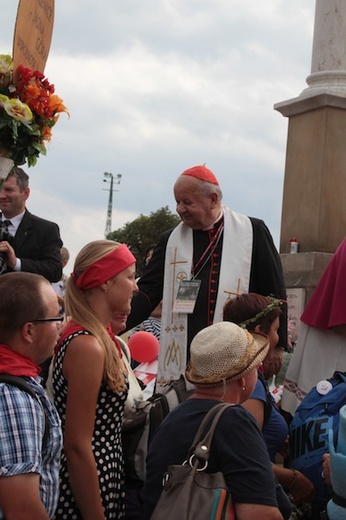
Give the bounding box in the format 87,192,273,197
126,213,287,348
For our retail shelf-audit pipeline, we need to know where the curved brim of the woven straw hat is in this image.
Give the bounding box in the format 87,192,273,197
185,331,270,386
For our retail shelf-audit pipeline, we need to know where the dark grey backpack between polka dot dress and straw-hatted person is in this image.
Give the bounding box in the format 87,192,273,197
122,376,194,487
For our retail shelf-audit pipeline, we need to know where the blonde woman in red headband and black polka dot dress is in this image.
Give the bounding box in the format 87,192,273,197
53,240,138,520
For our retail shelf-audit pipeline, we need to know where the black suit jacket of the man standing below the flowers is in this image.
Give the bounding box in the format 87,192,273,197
0,209,63,282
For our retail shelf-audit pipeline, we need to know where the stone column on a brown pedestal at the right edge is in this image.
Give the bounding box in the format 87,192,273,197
274,0,346,253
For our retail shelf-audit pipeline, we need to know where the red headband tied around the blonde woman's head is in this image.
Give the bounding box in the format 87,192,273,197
71,244,136,290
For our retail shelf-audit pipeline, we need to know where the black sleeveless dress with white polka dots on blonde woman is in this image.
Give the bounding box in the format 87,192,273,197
53,330,127,520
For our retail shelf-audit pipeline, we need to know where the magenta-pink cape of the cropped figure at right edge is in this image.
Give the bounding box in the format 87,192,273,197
301,238,346,329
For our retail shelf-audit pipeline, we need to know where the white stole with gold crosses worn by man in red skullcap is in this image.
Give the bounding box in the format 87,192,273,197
157,207,253,389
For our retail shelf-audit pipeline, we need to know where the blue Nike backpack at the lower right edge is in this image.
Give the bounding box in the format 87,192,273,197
289,372,346,503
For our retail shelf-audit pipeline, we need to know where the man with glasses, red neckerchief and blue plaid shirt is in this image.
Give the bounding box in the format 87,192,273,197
0,272,62,520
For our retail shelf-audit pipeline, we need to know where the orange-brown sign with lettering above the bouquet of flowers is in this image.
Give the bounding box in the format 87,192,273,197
13,0,54,82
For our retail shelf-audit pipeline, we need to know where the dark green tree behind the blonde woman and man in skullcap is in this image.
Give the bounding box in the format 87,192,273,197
107,206,180,276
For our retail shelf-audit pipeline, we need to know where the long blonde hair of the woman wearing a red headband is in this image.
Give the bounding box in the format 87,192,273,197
66,240,126,392
